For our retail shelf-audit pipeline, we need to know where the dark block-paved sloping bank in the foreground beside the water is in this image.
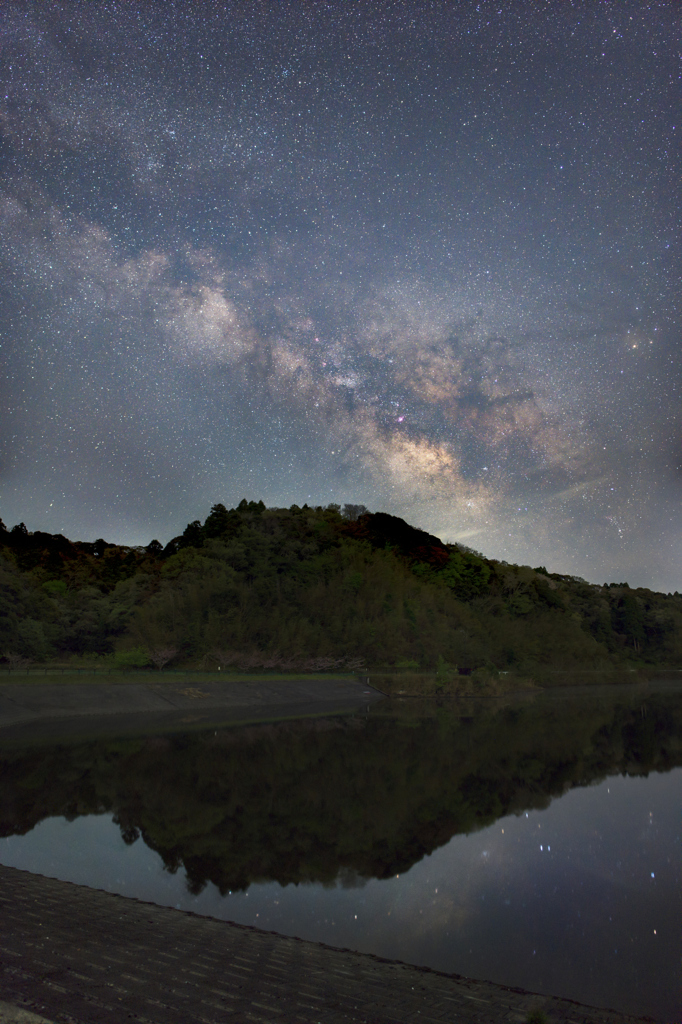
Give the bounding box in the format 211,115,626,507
0,867,655,1024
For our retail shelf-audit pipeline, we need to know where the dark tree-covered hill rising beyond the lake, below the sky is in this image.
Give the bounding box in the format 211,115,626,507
0,501,682,677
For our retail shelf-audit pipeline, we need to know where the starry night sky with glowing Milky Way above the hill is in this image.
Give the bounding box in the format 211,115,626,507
0,0,682,591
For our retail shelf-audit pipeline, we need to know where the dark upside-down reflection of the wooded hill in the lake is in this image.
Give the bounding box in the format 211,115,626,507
0,690,682,892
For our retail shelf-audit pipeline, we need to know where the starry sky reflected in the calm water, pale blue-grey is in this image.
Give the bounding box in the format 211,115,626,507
0,769,682,1019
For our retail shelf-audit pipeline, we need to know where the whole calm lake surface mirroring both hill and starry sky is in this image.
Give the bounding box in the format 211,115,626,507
0,684,682,1019
